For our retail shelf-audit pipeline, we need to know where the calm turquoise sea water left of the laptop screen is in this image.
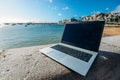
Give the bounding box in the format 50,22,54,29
0,24,64,49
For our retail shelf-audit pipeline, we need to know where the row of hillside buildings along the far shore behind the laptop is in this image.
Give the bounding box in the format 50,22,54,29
59,12,120,25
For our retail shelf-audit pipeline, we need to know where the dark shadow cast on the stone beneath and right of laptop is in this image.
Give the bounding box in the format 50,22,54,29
51,51,120,80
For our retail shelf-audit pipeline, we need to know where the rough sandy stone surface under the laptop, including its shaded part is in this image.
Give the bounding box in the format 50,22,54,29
0,36,120,80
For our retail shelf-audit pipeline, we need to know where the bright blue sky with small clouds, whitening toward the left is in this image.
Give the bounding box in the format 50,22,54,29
0,0,120,22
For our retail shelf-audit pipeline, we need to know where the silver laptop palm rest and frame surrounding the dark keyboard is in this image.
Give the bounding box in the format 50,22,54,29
40,44,97,76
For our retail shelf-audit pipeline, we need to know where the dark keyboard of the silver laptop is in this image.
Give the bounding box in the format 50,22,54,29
51,45,92,62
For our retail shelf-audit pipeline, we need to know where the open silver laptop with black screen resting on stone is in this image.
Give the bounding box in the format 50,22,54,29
40,21,105,76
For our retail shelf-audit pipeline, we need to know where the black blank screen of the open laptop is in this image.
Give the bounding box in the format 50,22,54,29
61,21,104,52
